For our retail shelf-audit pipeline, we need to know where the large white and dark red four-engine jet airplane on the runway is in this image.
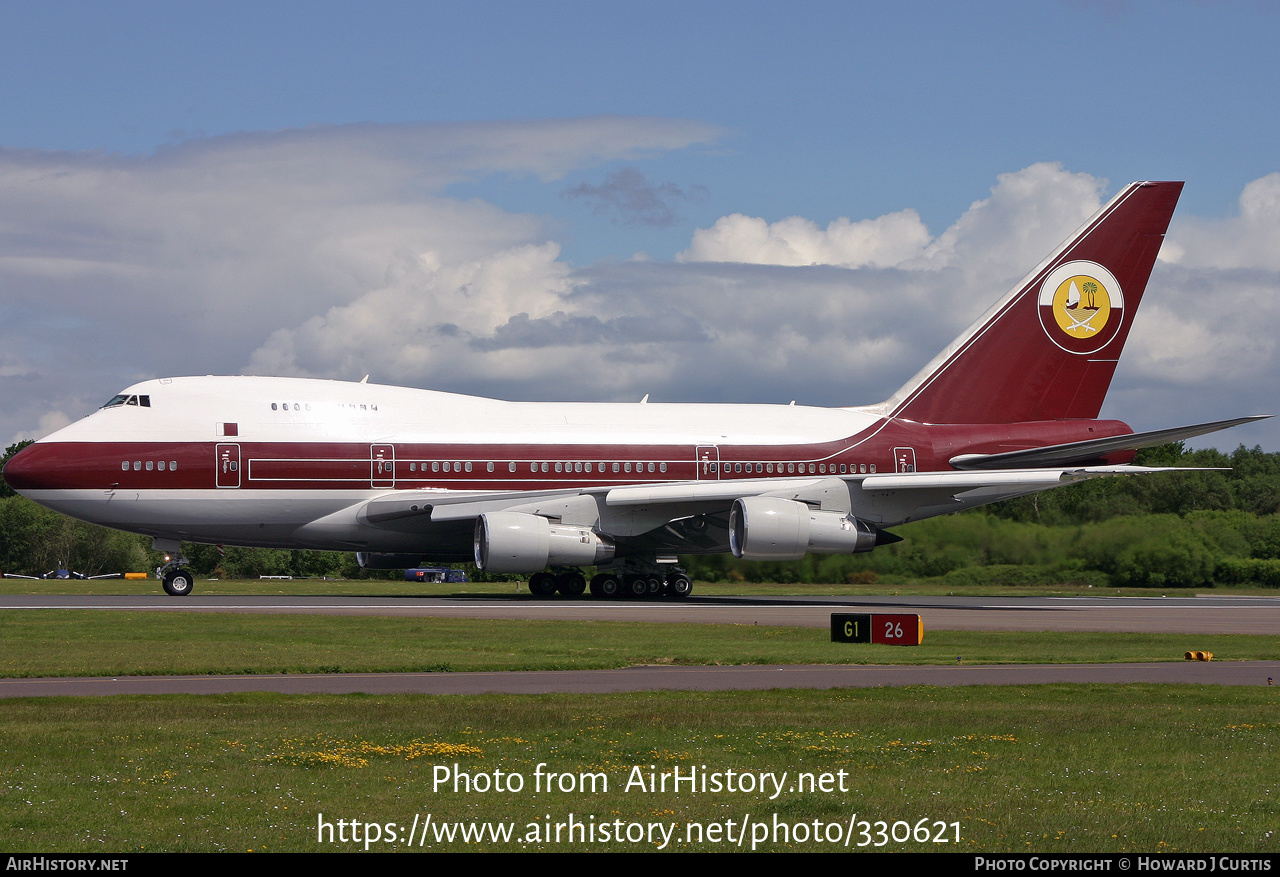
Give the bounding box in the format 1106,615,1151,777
4,182,1266,599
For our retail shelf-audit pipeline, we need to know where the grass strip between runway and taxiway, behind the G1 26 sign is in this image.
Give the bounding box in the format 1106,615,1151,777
0,609,1280,676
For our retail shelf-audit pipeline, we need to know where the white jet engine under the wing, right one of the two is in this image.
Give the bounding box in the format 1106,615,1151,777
728,497,876,561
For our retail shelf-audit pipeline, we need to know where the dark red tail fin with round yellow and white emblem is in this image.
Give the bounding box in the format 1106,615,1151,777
884,183,1183,424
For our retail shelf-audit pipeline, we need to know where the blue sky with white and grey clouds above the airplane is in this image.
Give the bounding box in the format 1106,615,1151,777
0,3,1280,449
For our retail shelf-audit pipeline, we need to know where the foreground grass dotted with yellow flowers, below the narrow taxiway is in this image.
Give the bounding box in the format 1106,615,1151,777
0,685,1280,854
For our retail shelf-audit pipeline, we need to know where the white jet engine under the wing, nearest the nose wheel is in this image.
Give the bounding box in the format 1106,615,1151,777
475,512,613,572
